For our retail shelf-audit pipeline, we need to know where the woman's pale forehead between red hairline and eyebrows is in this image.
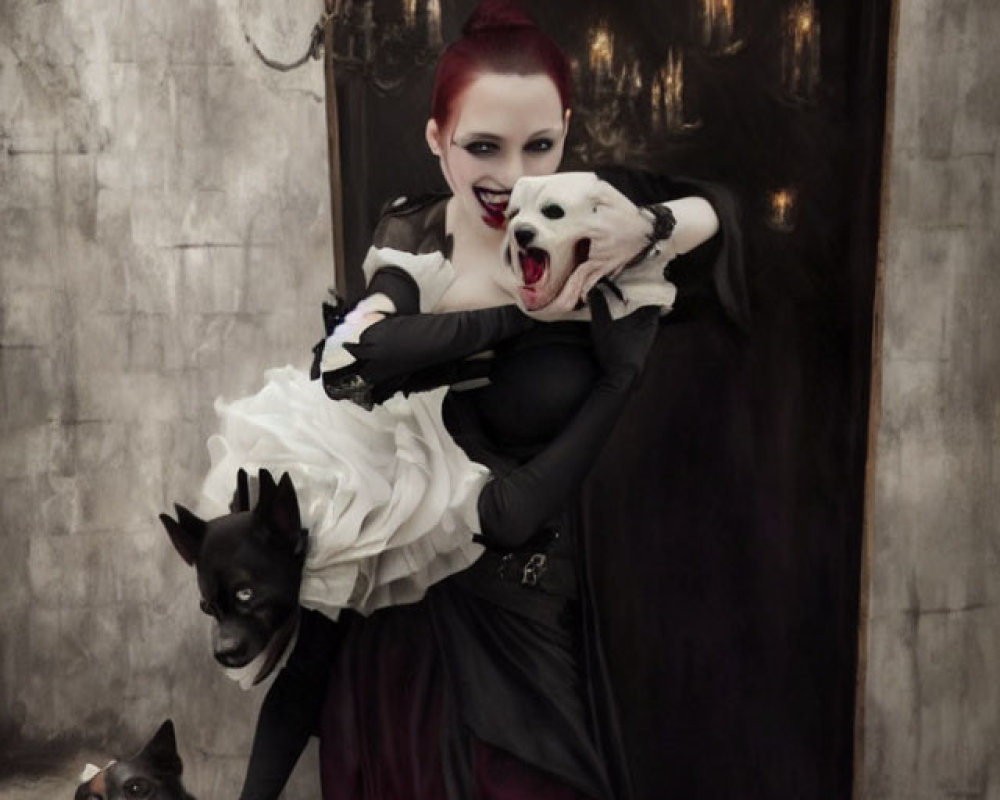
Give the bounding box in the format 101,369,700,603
453,72,563,137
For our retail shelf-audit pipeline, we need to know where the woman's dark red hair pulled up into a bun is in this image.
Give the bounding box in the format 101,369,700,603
431,0,573,128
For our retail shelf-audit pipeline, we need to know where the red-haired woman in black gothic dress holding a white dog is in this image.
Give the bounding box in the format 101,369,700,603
229,0,743,800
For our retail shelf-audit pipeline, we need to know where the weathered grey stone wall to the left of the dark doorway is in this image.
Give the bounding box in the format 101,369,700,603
0,0,333,798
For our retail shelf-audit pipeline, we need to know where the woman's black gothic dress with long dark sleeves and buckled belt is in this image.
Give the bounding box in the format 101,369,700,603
242,167,742,800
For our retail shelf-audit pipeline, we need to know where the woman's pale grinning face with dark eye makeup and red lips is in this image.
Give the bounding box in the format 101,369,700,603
427,72,569,232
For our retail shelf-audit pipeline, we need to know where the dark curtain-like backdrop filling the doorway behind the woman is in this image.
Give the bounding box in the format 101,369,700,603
339,0,890,800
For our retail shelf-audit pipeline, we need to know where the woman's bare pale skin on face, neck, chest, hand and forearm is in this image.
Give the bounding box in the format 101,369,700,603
366,72,719,322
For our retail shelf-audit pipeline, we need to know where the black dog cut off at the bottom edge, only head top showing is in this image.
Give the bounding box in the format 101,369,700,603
75,719,195,800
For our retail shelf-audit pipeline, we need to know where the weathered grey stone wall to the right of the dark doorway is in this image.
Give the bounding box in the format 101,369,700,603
859,0,1000,800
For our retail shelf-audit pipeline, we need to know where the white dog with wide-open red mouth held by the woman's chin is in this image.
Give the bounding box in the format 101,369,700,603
499,172,684,319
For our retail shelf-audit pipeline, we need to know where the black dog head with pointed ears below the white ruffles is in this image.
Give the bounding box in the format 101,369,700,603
160,469,307,682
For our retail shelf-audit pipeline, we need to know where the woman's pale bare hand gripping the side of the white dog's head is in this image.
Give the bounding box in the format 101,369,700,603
567,181,653,300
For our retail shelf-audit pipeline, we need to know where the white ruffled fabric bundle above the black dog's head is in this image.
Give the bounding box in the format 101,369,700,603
199,366,490,619
